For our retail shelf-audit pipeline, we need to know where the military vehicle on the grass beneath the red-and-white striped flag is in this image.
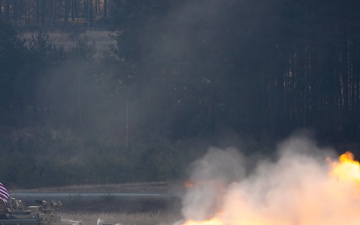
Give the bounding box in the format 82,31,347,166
0,198,82,225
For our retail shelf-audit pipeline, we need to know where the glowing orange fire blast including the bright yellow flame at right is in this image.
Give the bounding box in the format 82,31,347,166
182,143,360,225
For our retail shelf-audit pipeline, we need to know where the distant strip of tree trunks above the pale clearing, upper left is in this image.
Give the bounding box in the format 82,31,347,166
0,0,112,29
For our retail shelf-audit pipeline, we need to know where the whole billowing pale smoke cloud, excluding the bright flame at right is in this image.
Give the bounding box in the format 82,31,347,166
183,134,360,225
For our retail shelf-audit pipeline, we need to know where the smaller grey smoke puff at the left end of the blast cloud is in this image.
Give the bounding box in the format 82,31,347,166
182,148,244,219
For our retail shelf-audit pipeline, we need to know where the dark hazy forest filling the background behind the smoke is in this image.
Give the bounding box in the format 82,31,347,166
0,0,360,187
